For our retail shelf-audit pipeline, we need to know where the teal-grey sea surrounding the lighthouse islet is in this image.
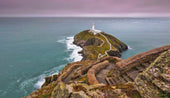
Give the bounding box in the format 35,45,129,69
0,17,170,98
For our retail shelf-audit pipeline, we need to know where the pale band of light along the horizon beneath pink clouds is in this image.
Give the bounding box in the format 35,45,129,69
0,13,170,18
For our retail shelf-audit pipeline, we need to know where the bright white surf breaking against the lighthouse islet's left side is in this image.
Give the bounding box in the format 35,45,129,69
66,37,83,62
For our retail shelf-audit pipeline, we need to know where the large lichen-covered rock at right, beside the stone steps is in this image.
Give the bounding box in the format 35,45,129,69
135,50,170,98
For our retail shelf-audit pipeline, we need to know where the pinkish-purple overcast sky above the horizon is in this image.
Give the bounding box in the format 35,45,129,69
0,0,170,17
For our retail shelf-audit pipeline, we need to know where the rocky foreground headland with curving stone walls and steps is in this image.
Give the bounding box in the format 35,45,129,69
26,45,170,98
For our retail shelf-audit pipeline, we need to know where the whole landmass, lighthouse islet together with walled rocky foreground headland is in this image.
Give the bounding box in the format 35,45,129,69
25,29,170,98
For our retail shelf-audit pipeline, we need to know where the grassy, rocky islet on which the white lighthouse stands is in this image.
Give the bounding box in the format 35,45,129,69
74,30,127,60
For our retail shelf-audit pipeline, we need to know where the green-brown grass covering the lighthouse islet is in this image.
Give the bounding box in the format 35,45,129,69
75,30,126,60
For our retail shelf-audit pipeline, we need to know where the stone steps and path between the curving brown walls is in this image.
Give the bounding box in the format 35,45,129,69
96,59,155,85
